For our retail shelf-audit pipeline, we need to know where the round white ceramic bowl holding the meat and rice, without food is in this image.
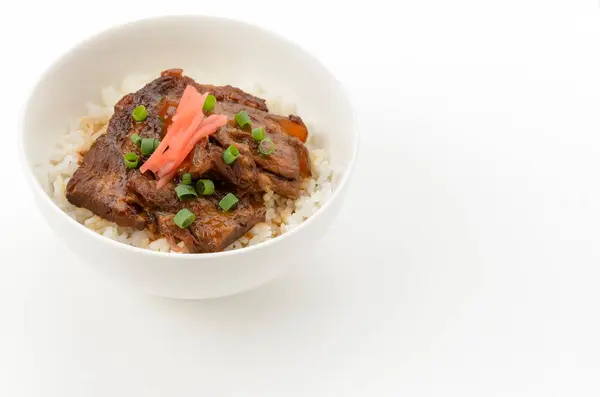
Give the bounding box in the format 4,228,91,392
21,16,358,299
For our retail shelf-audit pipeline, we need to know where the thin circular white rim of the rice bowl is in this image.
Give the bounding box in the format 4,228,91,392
18,14,360,260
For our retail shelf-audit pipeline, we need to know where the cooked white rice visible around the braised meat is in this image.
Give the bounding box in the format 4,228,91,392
37,75,333,252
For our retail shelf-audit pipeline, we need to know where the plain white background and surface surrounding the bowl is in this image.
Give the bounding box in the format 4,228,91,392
0,0,600,397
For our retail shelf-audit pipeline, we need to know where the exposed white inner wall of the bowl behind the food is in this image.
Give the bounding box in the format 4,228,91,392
23,16,357,196
